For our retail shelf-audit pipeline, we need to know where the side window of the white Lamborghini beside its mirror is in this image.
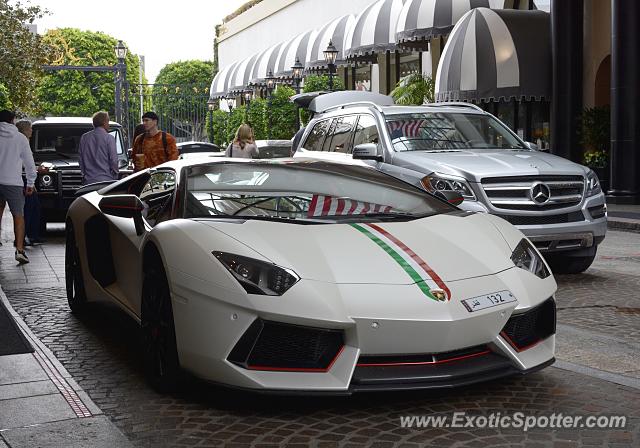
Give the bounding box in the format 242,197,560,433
139,171,176,226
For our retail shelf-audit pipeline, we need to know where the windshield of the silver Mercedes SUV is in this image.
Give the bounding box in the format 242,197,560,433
387,112,527,151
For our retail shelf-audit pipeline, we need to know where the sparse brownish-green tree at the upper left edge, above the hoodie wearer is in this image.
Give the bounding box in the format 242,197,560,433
0,0,51,112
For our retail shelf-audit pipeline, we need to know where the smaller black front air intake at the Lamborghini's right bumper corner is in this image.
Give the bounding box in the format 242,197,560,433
500,298,556,352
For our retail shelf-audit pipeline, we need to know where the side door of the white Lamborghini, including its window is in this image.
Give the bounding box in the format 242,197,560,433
105,168,176,316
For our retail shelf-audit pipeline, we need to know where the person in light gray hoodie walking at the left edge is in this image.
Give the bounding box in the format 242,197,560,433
0,109,37,264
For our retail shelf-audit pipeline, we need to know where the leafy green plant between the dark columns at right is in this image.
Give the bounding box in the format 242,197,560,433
580,106,611,191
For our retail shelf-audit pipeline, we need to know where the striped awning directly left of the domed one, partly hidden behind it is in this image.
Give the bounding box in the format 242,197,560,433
396,0,504,50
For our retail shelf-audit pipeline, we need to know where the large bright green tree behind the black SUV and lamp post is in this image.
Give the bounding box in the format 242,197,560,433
36,28,139,116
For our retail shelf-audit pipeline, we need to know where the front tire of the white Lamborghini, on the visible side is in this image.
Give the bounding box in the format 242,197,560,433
141,261,180,392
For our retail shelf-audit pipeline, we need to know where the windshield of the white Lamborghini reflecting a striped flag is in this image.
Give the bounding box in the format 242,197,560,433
185,162,454,223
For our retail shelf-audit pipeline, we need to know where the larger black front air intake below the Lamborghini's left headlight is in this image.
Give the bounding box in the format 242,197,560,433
227,319,344,372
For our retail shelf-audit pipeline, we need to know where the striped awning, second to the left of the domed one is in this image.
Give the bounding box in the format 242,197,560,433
344,0,404,60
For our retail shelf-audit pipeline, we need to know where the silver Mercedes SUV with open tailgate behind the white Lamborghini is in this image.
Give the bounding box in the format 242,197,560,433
293,91,607,273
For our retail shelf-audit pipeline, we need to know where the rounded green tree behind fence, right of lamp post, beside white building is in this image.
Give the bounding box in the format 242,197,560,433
152,60,214,140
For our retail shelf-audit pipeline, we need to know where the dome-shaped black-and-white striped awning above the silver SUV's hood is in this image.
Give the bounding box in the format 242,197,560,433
436,8,551,101
